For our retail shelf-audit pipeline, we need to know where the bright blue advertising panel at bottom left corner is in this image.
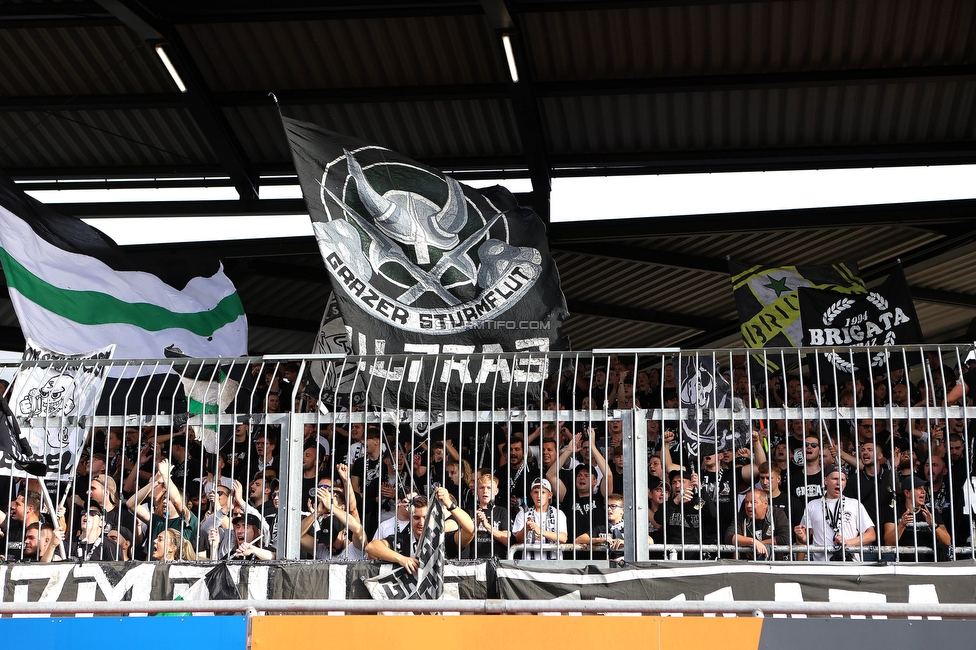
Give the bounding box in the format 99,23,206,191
0,616,247,650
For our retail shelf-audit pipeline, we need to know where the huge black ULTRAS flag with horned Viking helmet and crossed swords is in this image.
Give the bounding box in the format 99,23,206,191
282,117,568,408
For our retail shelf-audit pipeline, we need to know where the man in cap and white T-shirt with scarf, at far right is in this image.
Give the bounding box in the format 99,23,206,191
793,465,878,562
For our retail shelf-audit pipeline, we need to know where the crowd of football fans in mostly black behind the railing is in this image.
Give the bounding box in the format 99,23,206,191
0,355,976,570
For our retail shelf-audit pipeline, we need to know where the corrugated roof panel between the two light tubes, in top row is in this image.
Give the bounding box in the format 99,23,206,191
180,15,508,90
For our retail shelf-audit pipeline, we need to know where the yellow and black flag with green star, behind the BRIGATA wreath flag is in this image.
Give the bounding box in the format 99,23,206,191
729,260,866,372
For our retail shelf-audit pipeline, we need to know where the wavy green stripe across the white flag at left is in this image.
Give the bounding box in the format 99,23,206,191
0,243,244,336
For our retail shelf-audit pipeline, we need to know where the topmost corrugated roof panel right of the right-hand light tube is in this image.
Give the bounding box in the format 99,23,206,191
522,0,976,81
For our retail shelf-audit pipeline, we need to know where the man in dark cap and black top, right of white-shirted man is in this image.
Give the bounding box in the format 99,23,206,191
883,474,952,562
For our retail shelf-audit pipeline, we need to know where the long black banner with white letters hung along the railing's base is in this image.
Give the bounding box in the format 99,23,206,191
0,561,976,604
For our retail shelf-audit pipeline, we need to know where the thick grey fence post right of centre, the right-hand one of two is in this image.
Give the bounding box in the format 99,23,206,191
620,409,648,562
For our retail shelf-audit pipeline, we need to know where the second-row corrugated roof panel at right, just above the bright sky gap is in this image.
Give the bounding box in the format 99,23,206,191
540,80,976,154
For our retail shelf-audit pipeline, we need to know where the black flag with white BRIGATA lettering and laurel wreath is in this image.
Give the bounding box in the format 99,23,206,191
800,265,923,377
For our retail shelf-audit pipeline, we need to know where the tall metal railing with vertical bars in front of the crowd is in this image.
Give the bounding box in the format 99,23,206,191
0,346,976,562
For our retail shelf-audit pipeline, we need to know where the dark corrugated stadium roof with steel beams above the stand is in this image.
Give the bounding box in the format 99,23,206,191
0,0,976,353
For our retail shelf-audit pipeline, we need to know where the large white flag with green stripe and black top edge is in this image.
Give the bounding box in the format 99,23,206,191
0,173,247,359
